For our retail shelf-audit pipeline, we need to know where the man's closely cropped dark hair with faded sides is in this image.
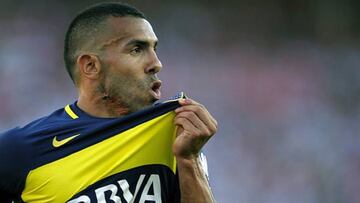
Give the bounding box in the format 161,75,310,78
64,2,145,82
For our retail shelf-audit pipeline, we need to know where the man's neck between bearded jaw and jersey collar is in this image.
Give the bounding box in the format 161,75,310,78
77,88,129,118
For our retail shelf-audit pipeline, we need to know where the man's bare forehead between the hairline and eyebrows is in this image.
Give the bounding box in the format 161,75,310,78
108,17,157,43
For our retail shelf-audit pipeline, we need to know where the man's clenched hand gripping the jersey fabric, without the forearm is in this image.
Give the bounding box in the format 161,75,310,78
173,99,217,159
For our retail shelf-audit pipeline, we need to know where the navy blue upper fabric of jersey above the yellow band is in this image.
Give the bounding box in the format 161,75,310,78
0,95,180,202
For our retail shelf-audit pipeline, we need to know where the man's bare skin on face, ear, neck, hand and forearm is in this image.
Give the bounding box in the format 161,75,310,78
75,17,217,202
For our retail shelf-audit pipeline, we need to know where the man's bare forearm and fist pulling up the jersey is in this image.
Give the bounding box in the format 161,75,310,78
173,99,217,203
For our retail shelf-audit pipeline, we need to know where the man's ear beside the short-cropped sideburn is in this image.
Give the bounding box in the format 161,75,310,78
76,54,101,80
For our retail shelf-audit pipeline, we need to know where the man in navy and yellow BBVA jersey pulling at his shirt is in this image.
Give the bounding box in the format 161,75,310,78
0,3,217,203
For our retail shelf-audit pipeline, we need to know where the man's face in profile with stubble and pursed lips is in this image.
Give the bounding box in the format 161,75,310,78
99,17,162,113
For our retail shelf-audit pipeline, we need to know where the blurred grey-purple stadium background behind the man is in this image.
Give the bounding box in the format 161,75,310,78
0,0,360,203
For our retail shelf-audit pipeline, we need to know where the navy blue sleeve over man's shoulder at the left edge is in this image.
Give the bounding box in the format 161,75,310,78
0,105,69,194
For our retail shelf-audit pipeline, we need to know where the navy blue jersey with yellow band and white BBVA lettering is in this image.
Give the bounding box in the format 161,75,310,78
0,95,183,203
